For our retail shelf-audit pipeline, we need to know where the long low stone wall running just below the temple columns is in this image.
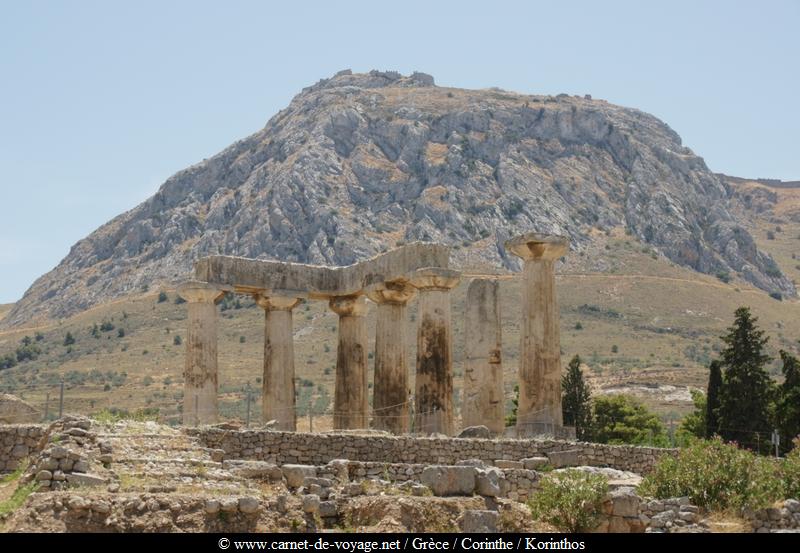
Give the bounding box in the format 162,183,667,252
191,428,676,474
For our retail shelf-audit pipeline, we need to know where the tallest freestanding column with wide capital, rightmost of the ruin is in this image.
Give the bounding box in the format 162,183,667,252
505,233,569,435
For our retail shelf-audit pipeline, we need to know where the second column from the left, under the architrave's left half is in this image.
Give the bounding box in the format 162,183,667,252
254,294,302,432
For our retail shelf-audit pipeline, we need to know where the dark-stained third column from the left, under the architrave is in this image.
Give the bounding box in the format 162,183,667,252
329,296,369,430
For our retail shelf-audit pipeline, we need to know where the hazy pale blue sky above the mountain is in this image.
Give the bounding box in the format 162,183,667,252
0,0,800,302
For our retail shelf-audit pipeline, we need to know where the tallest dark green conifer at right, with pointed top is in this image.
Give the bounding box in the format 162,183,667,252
717,307,771,449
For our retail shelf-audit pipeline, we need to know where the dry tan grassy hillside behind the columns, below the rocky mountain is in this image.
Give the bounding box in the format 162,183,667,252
0,215,800,429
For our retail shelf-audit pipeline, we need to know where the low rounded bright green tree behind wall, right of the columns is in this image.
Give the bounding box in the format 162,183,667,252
593,394,668,445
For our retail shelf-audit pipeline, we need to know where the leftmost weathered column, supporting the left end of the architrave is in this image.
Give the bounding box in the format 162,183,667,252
178,281,225,426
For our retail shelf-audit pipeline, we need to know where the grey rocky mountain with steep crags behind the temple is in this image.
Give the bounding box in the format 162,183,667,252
3,71,795,326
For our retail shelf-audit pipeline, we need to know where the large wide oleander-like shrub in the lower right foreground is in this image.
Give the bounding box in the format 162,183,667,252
639,438,784,511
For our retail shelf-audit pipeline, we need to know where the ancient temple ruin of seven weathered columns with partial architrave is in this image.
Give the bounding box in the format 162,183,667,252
179,233,570,436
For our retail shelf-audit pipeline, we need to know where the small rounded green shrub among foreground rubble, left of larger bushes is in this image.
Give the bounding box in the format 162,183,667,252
528,469,608,532
